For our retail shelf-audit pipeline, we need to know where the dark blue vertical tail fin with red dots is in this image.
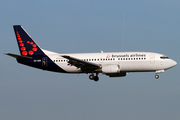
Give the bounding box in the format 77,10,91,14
13,25,44,57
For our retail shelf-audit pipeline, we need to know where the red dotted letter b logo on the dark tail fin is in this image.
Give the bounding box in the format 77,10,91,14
16,31,37,55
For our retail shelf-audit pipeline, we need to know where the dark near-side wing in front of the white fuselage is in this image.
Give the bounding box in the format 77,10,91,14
62,55,100,72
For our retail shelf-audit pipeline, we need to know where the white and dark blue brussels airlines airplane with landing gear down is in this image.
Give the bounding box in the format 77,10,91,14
4,25,177,81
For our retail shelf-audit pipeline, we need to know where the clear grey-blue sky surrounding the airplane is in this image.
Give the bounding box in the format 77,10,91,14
0,0,180,120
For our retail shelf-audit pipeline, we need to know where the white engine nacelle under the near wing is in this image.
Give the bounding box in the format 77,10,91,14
102,65,120,74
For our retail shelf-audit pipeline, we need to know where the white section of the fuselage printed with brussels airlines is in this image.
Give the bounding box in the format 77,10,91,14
44,51,177,73
